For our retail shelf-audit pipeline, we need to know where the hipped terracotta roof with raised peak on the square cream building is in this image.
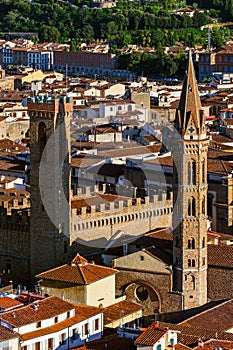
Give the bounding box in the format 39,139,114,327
36,263,117,285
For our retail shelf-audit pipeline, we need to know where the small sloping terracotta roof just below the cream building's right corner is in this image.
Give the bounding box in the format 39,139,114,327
104,300,142,325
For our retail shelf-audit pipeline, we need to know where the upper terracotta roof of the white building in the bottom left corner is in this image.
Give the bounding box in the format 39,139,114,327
0,296,74,327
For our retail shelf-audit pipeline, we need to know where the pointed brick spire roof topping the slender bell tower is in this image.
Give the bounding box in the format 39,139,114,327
175,50,204,135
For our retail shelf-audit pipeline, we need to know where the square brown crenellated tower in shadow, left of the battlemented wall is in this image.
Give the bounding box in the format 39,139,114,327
28,96,73,280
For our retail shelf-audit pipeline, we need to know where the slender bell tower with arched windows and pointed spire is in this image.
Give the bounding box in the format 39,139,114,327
172,51,209,309
